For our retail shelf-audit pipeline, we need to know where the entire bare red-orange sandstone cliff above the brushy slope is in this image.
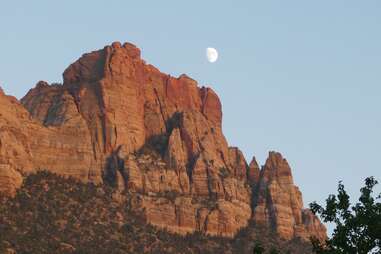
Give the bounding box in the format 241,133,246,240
0,42,325,239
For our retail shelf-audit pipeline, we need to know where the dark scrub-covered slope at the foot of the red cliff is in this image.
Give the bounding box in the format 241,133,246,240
0,171,310,254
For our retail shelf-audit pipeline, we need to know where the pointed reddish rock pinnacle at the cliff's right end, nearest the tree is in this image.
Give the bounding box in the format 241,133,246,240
253,152,326,239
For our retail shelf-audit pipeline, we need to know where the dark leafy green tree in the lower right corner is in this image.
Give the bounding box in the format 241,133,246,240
310,177,381,254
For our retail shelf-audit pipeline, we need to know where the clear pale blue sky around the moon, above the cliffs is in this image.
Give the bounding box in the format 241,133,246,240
0,0,381,213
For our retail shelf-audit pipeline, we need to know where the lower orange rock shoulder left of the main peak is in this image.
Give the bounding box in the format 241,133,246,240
0,82,101,182
